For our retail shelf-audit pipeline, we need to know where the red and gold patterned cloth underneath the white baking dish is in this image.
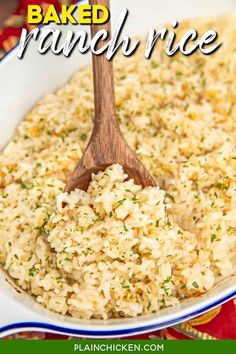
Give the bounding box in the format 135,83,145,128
0,0,236,339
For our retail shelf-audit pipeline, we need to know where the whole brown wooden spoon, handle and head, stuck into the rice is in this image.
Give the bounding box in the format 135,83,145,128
65,0,156,192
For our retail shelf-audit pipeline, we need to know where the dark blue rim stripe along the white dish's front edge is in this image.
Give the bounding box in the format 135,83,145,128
0,290,236,337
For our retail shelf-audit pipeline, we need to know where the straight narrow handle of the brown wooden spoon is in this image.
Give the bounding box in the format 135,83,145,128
89,0,117,130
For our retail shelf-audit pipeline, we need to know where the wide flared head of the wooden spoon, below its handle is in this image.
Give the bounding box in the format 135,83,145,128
65,121,156,192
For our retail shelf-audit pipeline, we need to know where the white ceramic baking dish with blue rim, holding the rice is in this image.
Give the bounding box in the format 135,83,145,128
0,0,236,338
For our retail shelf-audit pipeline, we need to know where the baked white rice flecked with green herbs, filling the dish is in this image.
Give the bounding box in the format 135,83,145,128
0,16,236,319
